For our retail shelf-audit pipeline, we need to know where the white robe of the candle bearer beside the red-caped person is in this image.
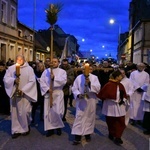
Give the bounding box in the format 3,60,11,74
71,74,101,135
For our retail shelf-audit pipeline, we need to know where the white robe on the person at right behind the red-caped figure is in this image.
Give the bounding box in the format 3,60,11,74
130,70,149,120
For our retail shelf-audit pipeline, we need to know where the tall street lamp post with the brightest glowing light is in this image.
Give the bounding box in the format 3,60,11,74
109,19,121,62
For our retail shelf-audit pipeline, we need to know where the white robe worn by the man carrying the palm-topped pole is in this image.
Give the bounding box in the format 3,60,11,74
40,68,67,131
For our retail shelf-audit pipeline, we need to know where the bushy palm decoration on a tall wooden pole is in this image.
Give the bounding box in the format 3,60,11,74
46,3,63,107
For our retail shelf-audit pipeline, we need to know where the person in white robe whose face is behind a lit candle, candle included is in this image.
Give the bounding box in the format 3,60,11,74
71,64,101,145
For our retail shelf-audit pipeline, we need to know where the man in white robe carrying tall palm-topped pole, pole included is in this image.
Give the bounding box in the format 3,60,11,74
40,4,67,137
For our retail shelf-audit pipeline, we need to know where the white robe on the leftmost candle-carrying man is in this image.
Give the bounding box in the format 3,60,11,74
4,62,37,134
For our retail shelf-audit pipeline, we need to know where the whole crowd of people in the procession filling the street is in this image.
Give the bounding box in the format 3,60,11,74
0,55,150,145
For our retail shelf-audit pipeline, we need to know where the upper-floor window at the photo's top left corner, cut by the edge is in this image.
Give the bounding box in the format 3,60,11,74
1,1,7,23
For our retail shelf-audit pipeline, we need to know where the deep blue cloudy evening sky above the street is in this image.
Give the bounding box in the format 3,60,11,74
18,0,131,58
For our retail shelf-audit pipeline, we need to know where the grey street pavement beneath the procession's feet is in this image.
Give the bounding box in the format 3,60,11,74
0,104,150,150
